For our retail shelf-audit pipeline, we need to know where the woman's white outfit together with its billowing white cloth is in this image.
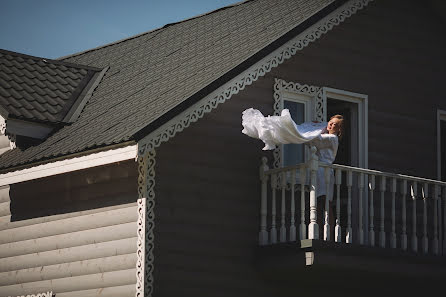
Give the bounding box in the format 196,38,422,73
242,108,338,200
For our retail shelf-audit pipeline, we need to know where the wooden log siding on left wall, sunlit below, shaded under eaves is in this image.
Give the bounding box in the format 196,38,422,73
0,161,137,297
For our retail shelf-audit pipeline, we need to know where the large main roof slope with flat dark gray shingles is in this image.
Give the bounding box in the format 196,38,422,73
0,0,336,168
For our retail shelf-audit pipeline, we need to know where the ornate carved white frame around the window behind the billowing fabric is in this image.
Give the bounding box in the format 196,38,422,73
273,78,326,168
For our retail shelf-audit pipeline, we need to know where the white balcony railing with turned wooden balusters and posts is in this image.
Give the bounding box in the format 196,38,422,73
259,147,446,255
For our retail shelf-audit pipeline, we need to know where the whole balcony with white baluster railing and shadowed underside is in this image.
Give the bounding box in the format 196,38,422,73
258,147,446,281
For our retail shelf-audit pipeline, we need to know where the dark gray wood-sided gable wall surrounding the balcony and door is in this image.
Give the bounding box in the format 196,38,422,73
154,0,446,297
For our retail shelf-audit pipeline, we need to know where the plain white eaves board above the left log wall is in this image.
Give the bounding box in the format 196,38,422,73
0,144,137,186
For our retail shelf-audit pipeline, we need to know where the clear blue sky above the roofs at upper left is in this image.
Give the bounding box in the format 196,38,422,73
0,0,240,59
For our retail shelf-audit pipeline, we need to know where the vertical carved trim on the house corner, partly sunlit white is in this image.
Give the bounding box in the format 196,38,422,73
136,150,156,297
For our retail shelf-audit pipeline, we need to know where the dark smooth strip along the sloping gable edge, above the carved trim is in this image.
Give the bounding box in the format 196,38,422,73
133,0,350,141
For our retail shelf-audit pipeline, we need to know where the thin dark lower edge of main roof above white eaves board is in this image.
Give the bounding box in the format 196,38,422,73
0,140,136,174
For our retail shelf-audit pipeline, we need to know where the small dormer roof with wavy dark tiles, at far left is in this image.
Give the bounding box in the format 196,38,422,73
0,49,100,123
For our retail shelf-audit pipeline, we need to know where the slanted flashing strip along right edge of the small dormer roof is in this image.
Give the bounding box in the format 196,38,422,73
62,66,110,123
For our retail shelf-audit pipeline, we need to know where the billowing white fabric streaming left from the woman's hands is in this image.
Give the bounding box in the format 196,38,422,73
242,108,327,150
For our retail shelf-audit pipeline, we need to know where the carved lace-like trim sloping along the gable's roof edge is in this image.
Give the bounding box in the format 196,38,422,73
138,0,372,155
